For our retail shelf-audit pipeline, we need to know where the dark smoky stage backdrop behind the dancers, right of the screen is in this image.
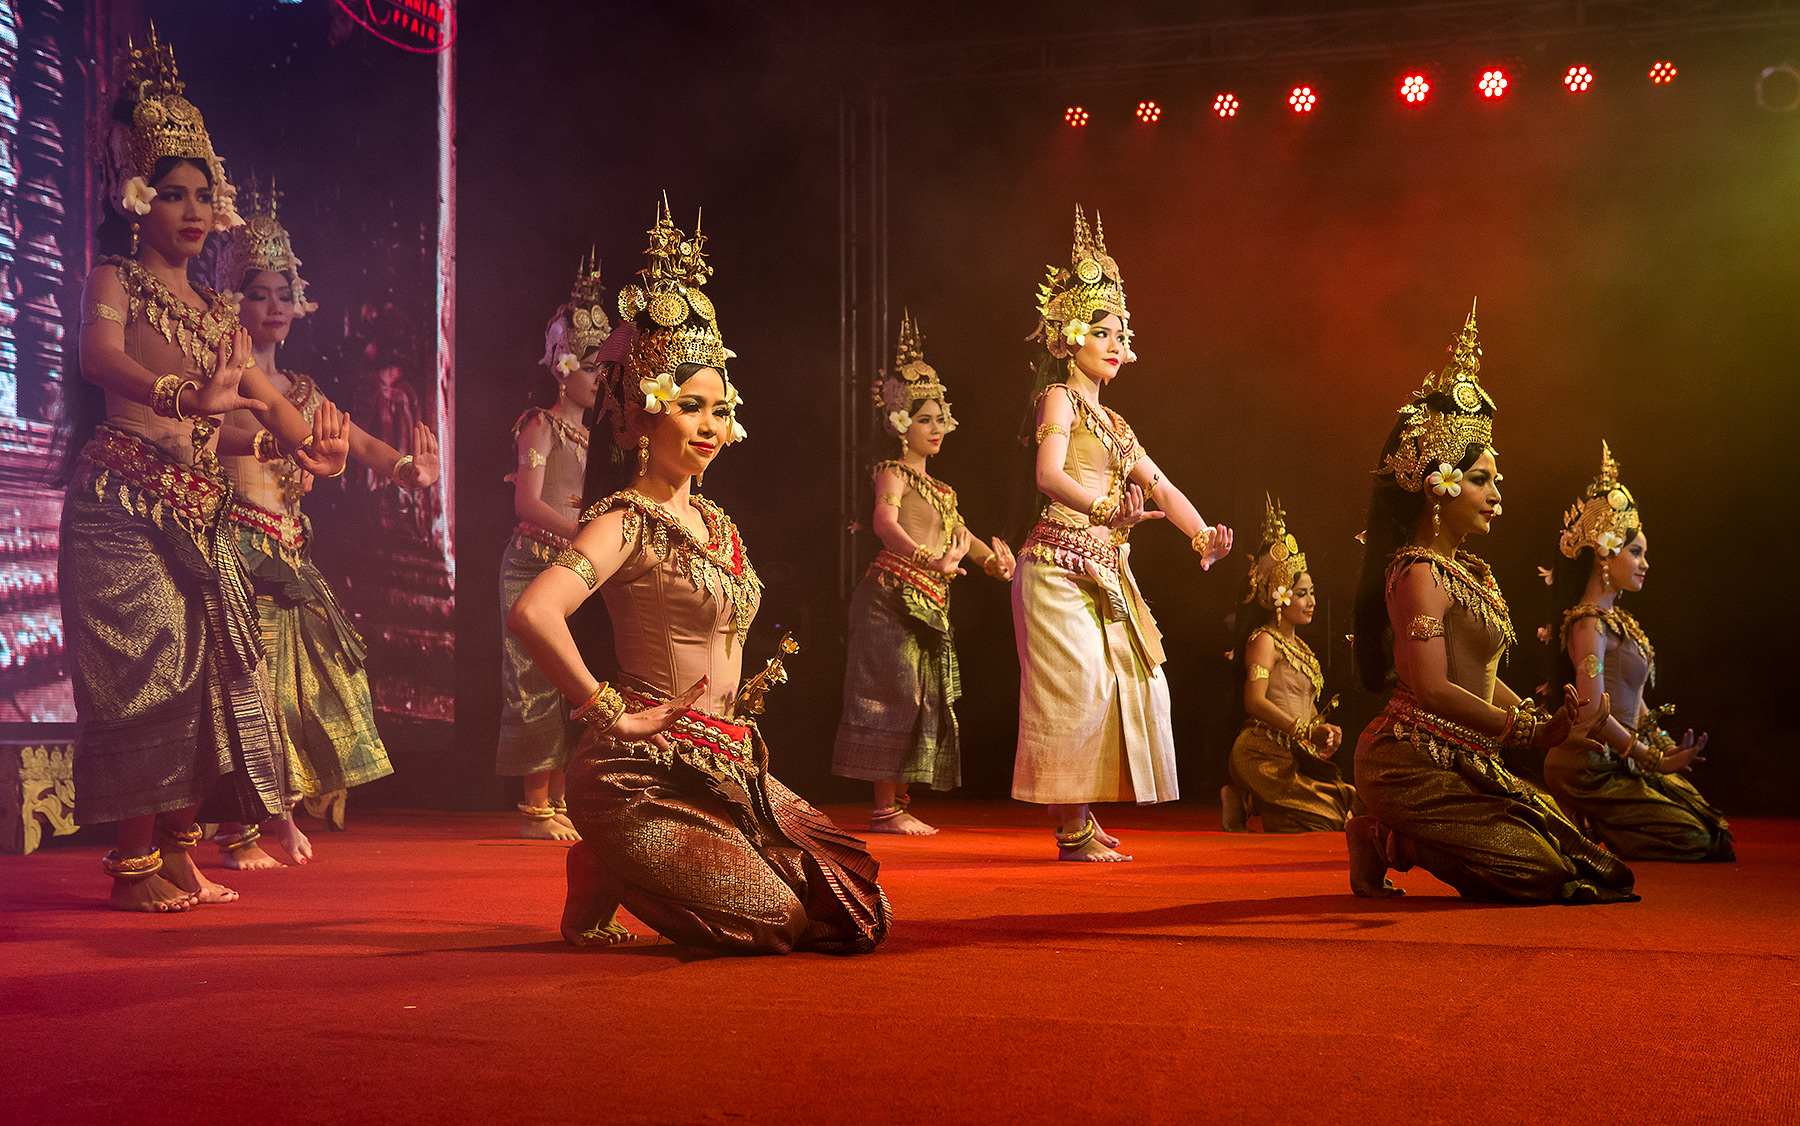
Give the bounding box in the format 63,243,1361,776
446,4,1800,811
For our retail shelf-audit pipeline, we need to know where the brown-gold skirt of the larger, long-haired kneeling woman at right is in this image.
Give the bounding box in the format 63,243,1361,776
1355,716,1633,903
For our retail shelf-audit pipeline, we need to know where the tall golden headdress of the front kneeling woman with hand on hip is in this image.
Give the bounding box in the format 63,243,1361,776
619,198,733,381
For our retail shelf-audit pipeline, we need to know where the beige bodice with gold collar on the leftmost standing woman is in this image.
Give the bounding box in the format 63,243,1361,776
94,259,238,466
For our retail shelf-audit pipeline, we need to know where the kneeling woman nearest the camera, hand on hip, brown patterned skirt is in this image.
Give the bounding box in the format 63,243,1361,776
509,203,887,953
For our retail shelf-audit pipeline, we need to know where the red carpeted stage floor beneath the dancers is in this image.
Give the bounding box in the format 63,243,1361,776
0,800,1800,1126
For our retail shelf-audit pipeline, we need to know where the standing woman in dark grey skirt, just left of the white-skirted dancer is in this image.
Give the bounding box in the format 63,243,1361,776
832,313,1013,836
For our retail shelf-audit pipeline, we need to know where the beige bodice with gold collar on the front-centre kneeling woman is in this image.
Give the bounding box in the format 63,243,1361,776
583,491,761,716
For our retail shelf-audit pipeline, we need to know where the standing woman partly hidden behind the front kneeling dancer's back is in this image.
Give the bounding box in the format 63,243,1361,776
497,254,612,840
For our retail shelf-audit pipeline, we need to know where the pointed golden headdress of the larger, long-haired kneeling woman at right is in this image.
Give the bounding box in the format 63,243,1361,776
1375,304,1494,493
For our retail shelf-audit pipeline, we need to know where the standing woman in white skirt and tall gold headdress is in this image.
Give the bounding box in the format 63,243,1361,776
1013,207,1231,862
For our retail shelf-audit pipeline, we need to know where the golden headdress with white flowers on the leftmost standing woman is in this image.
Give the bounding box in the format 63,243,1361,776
94,25,243,230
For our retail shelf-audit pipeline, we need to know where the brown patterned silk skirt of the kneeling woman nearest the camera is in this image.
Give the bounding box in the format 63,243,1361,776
569,723,889,953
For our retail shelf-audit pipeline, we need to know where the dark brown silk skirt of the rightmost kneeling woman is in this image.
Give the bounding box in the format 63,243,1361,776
1544,746,1737,860
